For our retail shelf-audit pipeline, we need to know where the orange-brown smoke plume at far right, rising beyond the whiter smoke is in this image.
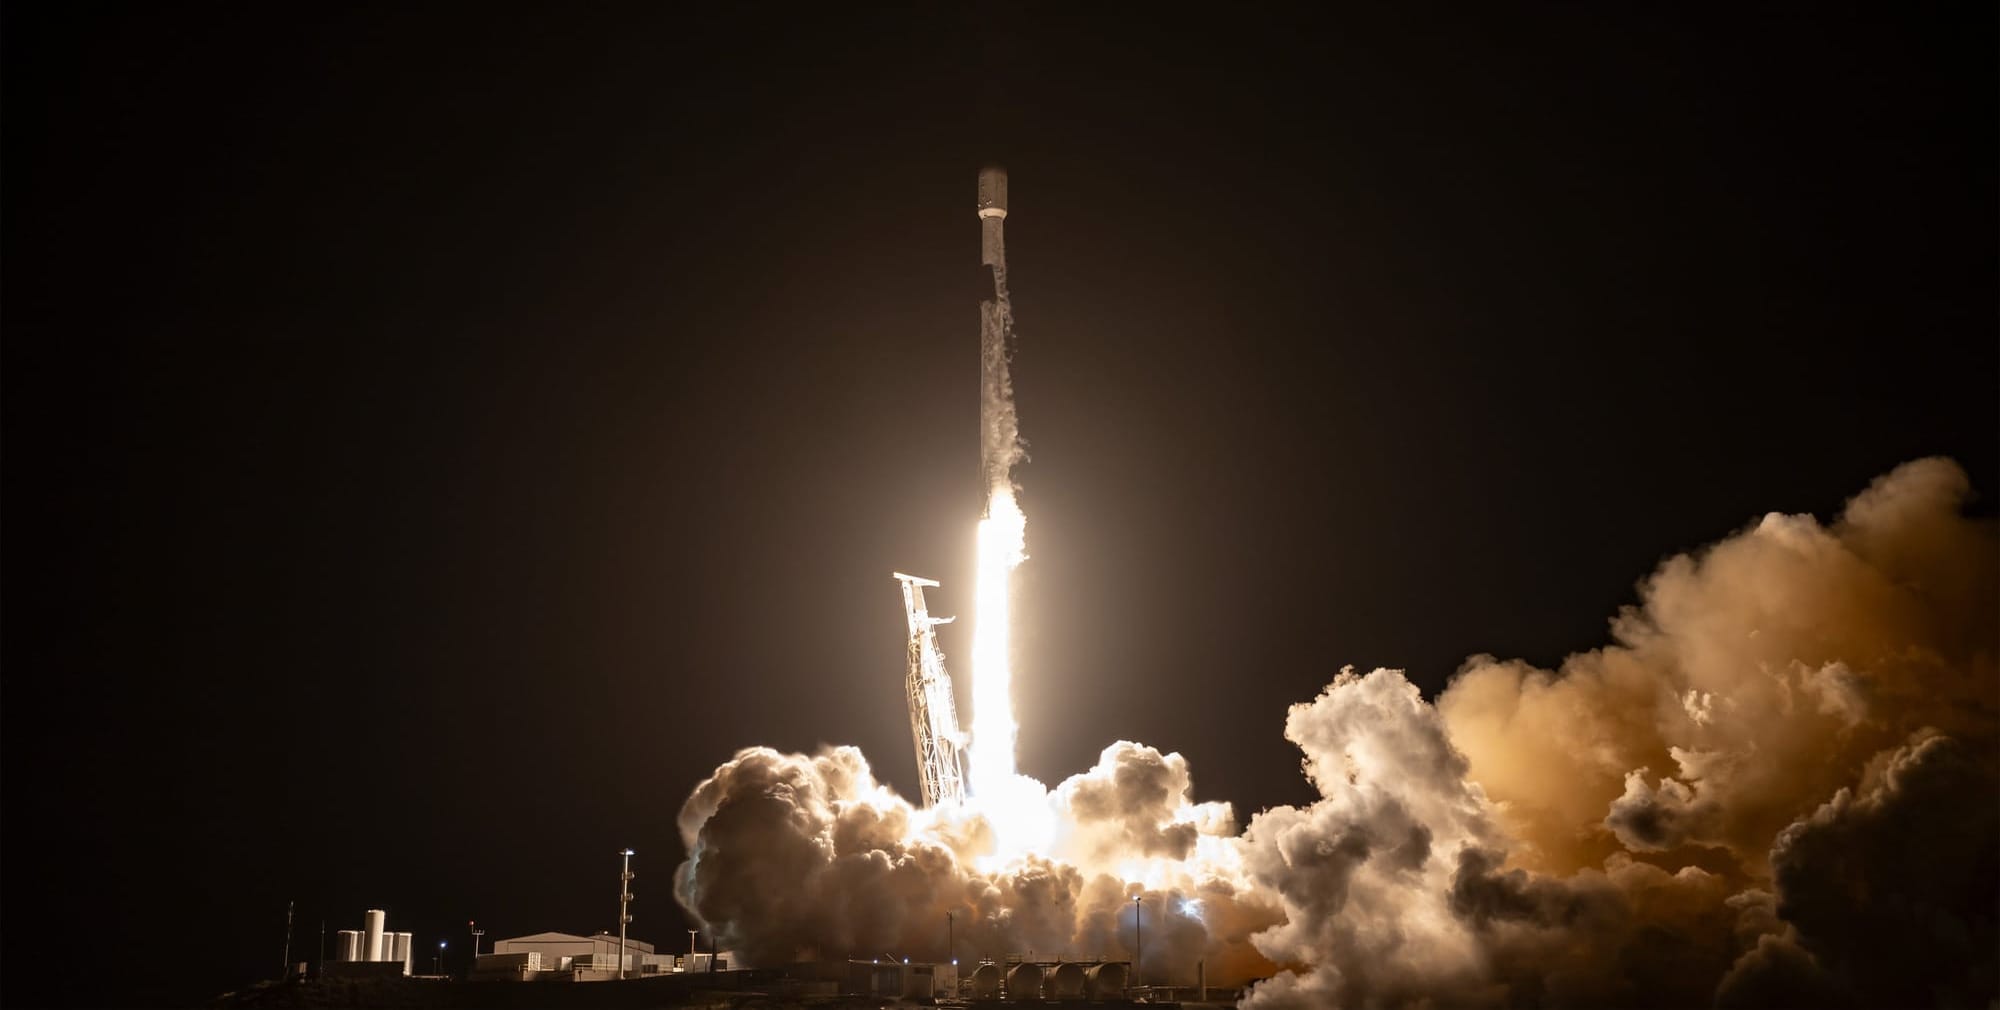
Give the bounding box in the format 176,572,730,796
1438,460,1996,878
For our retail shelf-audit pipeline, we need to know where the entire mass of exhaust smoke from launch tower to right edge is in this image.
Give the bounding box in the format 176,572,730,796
680,460,2000,1008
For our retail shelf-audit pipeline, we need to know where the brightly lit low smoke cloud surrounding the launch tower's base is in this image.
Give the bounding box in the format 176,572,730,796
676,742,1276,982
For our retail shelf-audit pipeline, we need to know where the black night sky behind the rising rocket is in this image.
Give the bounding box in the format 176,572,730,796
0,4,2000,1004
